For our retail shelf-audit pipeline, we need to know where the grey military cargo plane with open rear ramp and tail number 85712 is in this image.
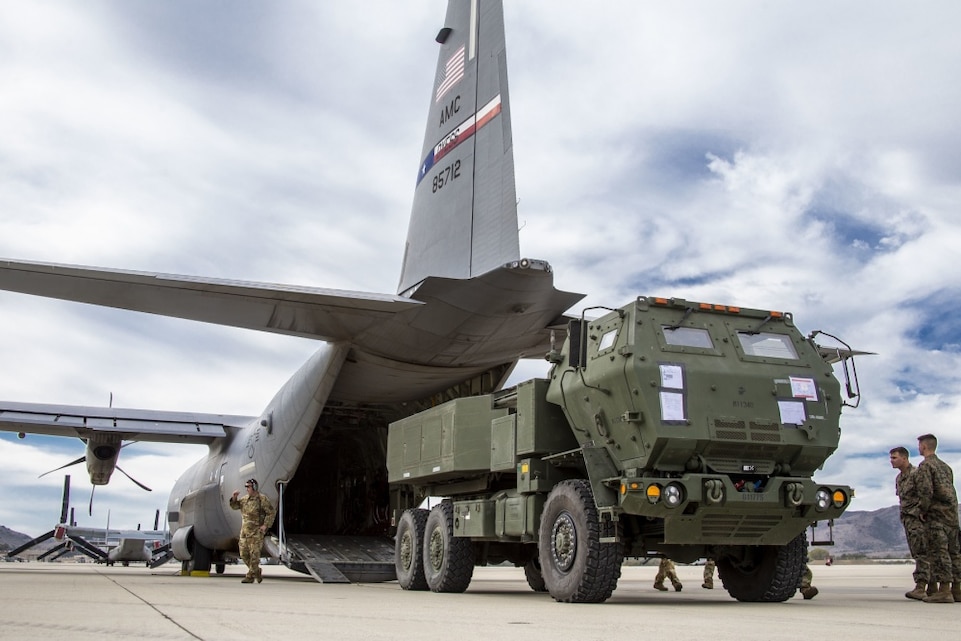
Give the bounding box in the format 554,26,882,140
0,0,583,581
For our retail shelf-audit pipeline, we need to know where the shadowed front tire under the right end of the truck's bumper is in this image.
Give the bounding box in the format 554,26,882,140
717,533,807,603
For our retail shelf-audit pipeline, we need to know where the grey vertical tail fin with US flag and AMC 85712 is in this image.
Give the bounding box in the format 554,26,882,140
397,0,520,294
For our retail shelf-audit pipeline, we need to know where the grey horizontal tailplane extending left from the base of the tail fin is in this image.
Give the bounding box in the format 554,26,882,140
0,259,421,341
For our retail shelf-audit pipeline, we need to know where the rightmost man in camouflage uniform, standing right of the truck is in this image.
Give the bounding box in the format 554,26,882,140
914,434,961,603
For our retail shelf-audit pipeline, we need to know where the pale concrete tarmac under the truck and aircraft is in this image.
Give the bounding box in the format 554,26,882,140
0,563,961,641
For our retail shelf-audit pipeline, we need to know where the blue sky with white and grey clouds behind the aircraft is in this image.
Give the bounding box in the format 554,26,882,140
0,0,961,534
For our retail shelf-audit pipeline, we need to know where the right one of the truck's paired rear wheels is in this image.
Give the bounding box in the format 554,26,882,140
424,501,474,592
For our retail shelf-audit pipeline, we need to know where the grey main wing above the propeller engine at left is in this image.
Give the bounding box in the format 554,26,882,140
0,401,255,444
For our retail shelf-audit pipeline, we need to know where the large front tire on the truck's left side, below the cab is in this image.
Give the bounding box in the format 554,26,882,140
537,479,624,603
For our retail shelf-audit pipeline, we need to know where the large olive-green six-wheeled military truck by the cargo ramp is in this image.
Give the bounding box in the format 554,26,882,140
387,297,859,602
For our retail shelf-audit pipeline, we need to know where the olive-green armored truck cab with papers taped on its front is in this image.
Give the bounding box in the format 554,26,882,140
560,298,851,556
